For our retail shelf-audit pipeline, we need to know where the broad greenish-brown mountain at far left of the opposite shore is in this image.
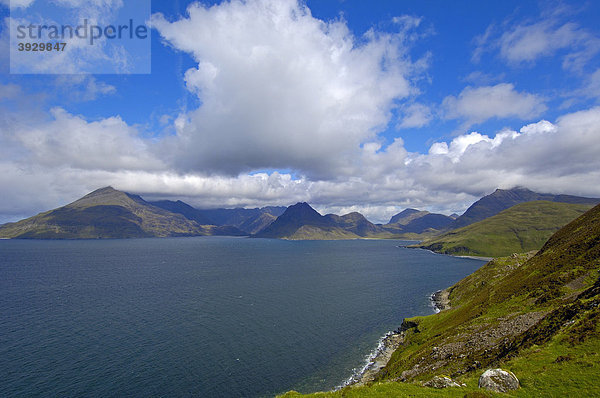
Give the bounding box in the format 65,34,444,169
0,187,246,239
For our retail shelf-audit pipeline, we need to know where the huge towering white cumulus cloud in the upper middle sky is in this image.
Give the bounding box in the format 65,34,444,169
152,0,422,178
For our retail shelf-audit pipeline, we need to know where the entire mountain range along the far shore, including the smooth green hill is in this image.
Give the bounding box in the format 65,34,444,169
0,187,600,246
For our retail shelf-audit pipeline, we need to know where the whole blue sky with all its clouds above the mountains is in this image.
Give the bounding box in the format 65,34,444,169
0,0,600,223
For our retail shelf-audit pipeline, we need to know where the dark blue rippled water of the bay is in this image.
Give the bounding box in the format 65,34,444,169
0,237,482,397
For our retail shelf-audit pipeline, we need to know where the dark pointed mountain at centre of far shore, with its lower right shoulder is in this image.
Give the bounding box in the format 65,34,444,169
255,203,392,240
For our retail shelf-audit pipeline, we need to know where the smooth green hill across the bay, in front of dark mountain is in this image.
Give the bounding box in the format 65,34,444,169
420,201,592,257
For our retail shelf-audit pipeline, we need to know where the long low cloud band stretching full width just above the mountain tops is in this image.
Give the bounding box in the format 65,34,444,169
0,107,600,222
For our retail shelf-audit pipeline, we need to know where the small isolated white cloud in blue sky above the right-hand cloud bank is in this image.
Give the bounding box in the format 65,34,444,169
442,83,547,126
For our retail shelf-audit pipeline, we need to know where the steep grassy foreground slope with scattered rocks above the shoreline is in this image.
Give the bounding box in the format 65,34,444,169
285,206,600,397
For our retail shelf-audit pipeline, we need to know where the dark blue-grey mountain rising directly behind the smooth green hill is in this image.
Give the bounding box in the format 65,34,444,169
450,188,600,229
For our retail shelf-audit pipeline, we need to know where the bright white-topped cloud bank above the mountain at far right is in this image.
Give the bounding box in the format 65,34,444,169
411,108,600,202
